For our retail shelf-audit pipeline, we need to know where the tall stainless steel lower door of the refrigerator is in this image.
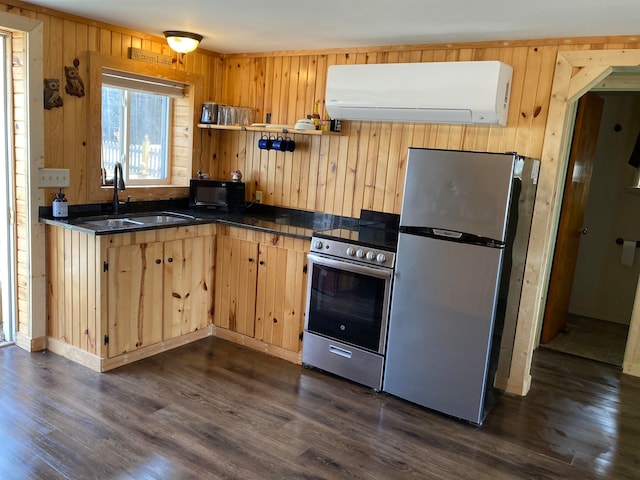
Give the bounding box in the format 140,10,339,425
383,234,503,424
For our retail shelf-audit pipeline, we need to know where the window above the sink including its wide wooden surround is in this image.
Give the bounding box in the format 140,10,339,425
86,52,204,203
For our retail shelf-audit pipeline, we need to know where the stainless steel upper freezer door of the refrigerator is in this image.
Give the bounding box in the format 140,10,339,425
400,148,515,241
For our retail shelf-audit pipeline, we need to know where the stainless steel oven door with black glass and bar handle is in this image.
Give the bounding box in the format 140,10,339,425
305,254,392,354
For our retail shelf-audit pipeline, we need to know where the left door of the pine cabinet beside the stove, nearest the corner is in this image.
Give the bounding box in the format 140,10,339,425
214,235,258,337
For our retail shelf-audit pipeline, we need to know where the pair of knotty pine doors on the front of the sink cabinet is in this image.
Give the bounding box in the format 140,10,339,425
106,236,214,358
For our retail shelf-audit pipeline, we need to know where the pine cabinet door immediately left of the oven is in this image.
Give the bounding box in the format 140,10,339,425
255,244,307,352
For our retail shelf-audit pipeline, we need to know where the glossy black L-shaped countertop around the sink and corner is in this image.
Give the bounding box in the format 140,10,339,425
39,199,358,240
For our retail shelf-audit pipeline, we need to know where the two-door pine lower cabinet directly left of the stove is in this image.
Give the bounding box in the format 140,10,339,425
214,226,309,362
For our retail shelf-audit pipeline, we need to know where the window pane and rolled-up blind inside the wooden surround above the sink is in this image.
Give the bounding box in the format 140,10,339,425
101,69,184,185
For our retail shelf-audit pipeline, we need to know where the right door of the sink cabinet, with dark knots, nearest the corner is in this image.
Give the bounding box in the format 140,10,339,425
163,236,214,340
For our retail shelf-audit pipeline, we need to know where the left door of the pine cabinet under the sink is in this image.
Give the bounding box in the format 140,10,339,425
107,242,163,358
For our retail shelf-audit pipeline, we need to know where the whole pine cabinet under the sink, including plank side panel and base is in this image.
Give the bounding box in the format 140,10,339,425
47,225,215,371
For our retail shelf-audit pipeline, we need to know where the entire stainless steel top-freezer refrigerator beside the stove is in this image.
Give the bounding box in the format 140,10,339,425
383,148,539,424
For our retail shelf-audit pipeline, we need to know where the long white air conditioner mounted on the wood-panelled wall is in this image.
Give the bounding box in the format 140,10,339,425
326,61,513,126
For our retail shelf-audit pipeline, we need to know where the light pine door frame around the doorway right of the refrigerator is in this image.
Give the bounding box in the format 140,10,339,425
507,50,640,395
